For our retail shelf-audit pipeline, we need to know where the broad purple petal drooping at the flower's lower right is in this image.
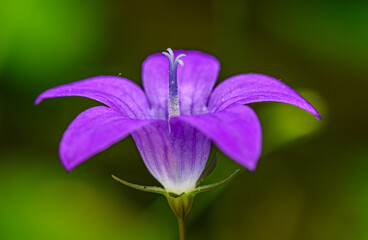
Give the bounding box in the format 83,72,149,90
171,105,262,170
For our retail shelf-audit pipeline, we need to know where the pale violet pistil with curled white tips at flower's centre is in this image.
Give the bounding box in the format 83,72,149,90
162,48,185,121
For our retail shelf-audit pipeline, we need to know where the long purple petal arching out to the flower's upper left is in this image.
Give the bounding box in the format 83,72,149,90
35,76,149,118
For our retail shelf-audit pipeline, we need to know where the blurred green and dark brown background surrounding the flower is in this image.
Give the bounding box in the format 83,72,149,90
0,0,368,240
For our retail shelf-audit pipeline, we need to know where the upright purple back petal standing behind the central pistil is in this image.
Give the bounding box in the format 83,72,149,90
142,50,220,119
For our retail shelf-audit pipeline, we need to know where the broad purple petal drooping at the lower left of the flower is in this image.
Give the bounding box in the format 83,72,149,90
59,106,155,171
